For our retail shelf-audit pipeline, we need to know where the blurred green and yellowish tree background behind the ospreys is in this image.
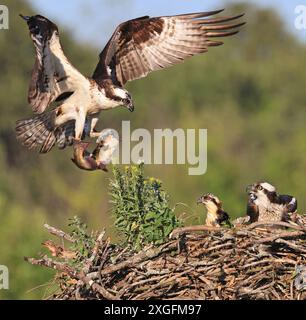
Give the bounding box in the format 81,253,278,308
0,0,306,299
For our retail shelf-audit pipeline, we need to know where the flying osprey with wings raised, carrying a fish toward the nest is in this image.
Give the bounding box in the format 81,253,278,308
16,10,244,153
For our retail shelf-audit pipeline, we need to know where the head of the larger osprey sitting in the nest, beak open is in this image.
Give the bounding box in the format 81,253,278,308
247,182,277,205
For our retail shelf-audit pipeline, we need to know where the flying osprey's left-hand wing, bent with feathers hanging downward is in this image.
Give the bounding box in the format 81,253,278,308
22,15,86,113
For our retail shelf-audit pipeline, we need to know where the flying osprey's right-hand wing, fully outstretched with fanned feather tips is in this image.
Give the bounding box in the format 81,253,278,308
93,10,244,86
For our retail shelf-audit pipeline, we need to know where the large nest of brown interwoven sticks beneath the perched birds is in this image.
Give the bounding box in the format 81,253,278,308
25,222,306,300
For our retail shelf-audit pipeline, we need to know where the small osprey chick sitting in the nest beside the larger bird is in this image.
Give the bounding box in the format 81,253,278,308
197,193,229,227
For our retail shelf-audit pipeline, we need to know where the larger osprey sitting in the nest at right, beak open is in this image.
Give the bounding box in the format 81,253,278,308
247,182,297,222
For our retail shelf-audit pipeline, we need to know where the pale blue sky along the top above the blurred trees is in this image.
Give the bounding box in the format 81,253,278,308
29,0,306,47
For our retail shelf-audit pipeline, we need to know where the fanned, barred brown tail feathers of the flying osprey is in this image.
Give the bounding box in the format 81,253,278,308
16,109,56,153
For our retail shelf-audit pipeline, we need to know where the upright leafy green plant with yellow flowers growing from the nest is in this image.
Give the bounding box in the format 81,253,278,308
109,164,180,250
